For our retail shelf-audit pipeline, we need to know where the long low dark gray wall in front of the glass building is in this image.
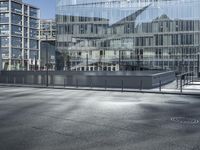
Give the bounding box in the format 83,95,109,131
0,71,175,89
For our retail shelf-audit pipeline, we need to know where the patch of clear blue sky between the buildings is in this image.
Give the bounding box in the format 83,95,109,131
23,0,56,19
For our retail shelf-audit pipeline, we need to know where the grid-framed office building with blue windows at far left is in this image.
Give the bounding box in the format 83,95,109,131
0,0,40,70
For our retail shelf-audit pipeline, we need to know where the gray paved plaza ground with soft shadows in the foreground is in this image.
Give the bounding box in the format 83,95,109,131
0,86,200,150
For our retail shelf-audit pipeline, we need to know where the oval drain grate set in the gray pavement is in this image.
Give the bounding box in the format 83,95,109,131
171,117,199,124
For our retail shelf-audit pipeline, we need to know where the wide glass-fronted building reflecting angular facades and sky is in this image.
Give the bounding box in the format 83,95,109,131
56,0,200,72
